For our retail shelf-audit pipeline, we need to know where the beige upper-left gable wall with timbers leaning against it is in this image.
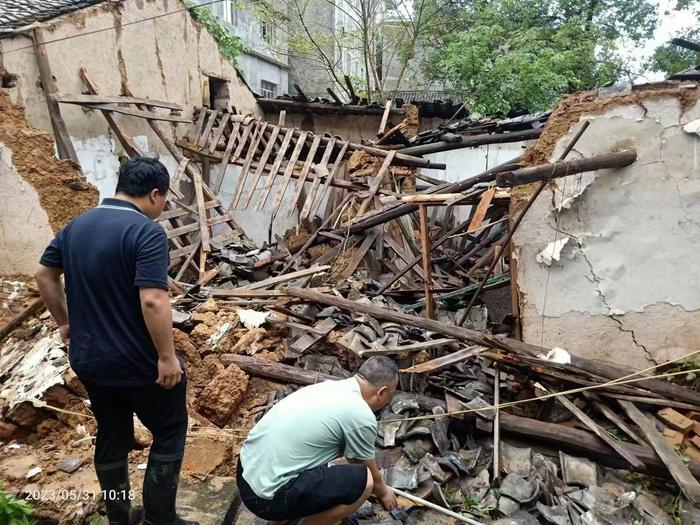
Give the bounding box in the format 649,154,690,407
0,0,262,197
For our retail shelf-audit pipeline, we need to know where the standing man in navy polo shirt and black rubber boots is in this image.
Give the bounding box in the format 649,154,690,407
36,157,196,525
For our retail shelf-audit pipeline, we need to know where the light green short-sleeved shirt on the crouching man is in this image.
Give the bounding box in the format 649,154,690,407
240,377,377,499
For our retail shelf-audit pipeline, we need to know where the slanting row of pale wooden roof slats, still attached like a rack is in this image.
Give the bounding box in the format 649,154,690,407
189,108,408,220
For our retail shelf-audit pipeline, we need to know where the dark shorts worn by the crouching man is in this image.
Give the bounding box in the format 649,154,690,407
236,459,367,521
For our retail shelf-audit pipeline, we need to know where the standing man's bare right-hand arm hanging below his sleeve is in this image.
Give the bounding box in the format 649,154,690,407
139,287,182,388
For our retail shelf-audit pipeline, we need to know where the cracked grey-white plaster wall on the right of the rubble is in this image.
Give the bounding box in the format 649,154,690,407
513,83,700,368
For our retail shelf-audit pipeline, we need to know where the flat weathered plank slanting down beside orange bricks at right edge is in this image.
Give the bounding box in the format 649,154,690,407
619,400,700,506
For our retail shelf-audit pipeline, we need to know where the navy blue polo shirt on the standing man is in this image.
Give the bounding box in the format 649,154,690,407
41,199,169,386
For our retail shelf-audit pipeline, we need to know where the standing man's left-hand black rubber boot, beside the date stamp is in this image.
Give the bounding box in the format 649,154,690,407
95,460,143,525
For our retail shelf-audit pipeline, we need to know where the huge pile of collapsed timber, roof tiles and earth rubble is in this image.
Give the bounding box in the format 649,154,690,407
0,79,700,525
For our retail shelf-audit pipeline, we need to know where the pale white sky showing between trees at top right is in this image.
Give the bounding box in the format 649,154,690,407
620,0,700,82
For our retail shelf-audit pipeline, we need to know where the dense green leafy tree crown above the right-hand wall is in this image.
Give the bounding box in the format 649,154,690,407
422,0,657,114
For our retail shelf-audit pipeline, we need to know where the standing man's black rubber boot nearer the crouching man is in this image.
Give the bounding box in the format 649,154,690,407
143,455,199,525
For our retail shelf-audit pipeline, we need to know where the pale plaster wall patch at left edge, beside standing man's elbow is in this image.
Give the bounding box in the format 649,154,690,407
0,142,53,275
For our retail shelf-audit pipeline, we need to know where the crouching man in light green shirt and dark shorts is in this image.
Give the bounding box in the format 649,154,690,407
236,356,398,525
